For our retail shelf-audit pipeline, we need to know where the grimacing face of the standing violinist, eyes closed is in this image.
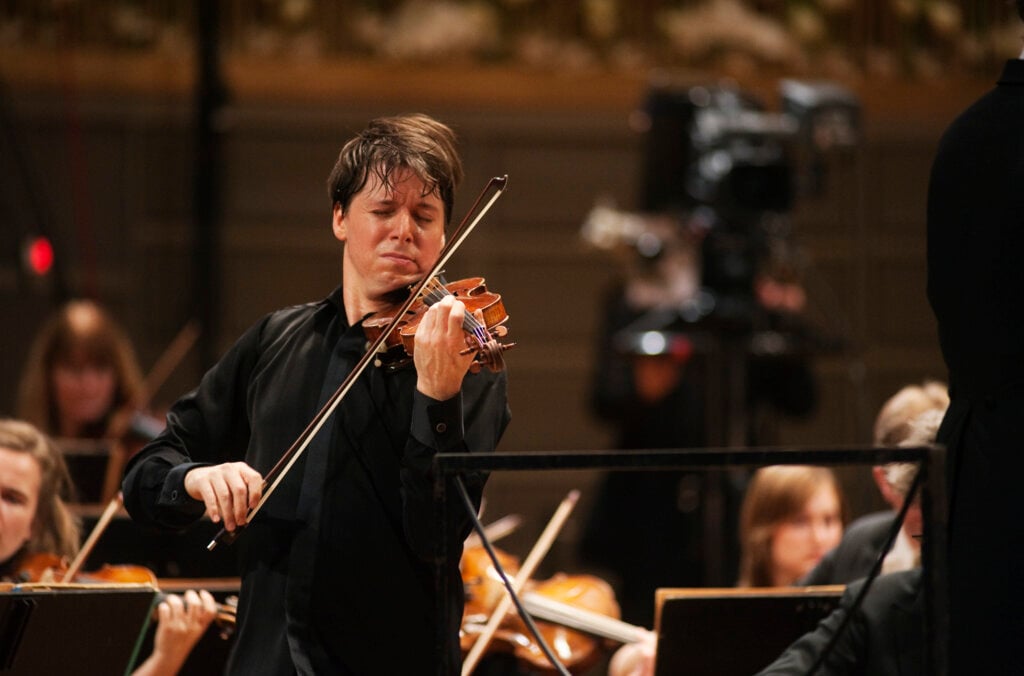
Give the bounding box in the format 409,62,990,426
334,169,444,303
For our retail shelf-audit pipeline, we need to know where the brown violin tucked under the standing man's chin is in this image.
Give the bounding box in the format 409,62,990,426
362,277,515,373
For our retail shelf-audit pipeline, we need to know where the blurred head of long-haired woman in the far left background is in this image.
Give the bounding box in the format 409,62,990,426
17,300,142,438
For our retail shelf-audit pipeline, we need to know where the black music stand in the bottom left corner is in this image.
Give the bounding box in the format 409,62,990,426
0,585,158,676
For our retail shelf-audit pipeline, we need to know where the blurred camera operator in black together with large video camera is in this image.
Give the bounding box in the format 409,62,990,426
581,84,816,626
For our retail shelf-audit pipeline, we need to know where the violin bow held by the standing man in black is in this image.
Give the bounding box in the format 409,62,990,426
206,175,508,551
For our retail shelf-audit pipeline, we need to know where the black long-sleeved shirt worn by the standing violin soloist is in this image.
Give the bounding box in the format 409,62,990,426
124,289,510,674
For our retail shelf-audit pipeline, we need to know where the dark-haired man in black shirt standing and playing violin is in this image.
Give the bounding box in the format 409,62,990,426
124,115,510,674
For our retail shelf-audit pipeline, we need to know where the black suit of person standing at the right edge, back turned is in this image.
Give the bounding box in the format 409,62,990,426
926,59,1024,675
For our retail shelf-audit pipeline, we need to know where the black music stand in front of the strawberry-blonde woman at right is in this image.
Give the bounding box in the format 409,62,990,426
654,585,845,676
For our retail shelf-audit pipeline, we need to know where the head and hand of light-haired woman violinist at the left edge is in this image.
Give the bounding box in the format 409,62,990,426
0,419,217,676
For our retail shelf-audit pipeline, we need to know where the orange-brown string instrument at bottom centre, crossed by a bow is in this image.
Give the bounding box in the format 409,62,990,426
460,547,644,673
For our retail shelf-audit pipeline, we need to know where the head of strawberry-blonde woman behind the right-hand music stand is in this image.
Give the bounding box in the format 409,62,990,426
739,465,847,587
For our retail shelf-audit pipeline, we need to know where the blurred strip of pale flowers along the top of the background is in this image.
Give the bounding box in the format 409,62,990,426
0,0,1024,78
